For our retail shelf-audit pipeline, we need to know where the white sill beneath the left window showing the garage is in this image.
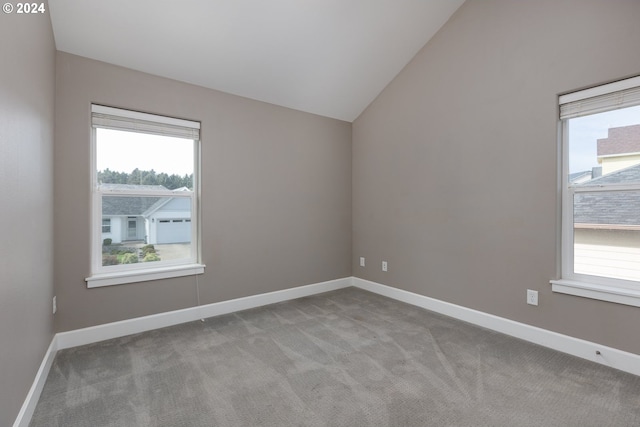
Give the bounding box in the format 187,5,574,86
84,264,205,288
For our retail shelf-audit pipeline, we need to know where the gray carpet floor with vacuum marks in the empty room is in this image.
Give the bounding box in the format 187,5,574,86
30,288,640,427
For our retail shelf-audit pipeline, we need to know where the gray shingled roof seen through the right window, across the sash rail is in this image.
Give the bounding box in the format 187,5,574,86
573,164,640,226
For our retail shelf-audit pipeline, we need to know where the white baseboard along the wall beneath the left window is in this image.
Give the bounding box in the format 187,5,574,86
56,277,351,350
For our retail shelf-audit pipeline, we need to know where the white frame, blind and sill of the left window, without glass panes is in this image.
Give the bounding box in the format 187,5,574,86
85,104,205,288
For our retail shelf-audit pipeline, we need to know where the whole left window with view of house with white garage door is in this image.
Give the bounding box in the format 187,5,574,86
86,105,204,287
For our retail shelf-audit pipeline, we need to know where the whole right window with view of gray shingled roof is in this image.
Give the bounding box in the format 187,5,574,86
551,77,640,307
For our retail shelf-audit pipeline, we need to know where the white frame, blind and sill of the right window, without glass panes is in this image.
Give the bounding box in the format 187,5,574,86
551,76,640,307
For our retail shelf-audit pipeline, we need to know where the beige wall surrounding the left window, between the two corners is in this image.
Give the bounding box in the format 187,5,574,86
55,52,351,331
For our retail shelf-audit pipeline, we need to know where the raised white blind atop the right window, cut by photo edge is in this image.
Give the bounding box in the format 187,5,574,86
559,77,640,120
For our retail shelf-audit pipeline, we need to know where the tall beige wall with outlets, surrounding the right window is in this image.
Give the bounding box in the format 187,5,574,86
352,0,640,354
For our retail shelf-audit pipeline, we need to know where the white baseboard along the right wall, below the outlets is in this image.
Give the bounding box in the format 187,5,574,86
352,277,640,376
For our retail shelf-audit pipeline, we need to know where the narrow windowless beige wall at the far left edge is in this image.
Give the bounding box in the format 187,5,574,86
0,4,55,426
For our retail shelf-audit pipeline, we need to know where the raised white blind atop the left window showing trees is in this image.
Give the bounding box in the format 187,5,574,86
91,105,200,141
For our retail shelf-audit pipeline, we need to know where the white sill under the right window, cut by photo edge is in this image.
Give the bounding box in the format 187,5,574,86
551,279,640,307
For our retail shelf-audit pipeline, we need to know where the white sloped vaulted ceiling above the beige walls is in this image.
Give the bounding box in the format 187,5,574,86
49,0,464,121
